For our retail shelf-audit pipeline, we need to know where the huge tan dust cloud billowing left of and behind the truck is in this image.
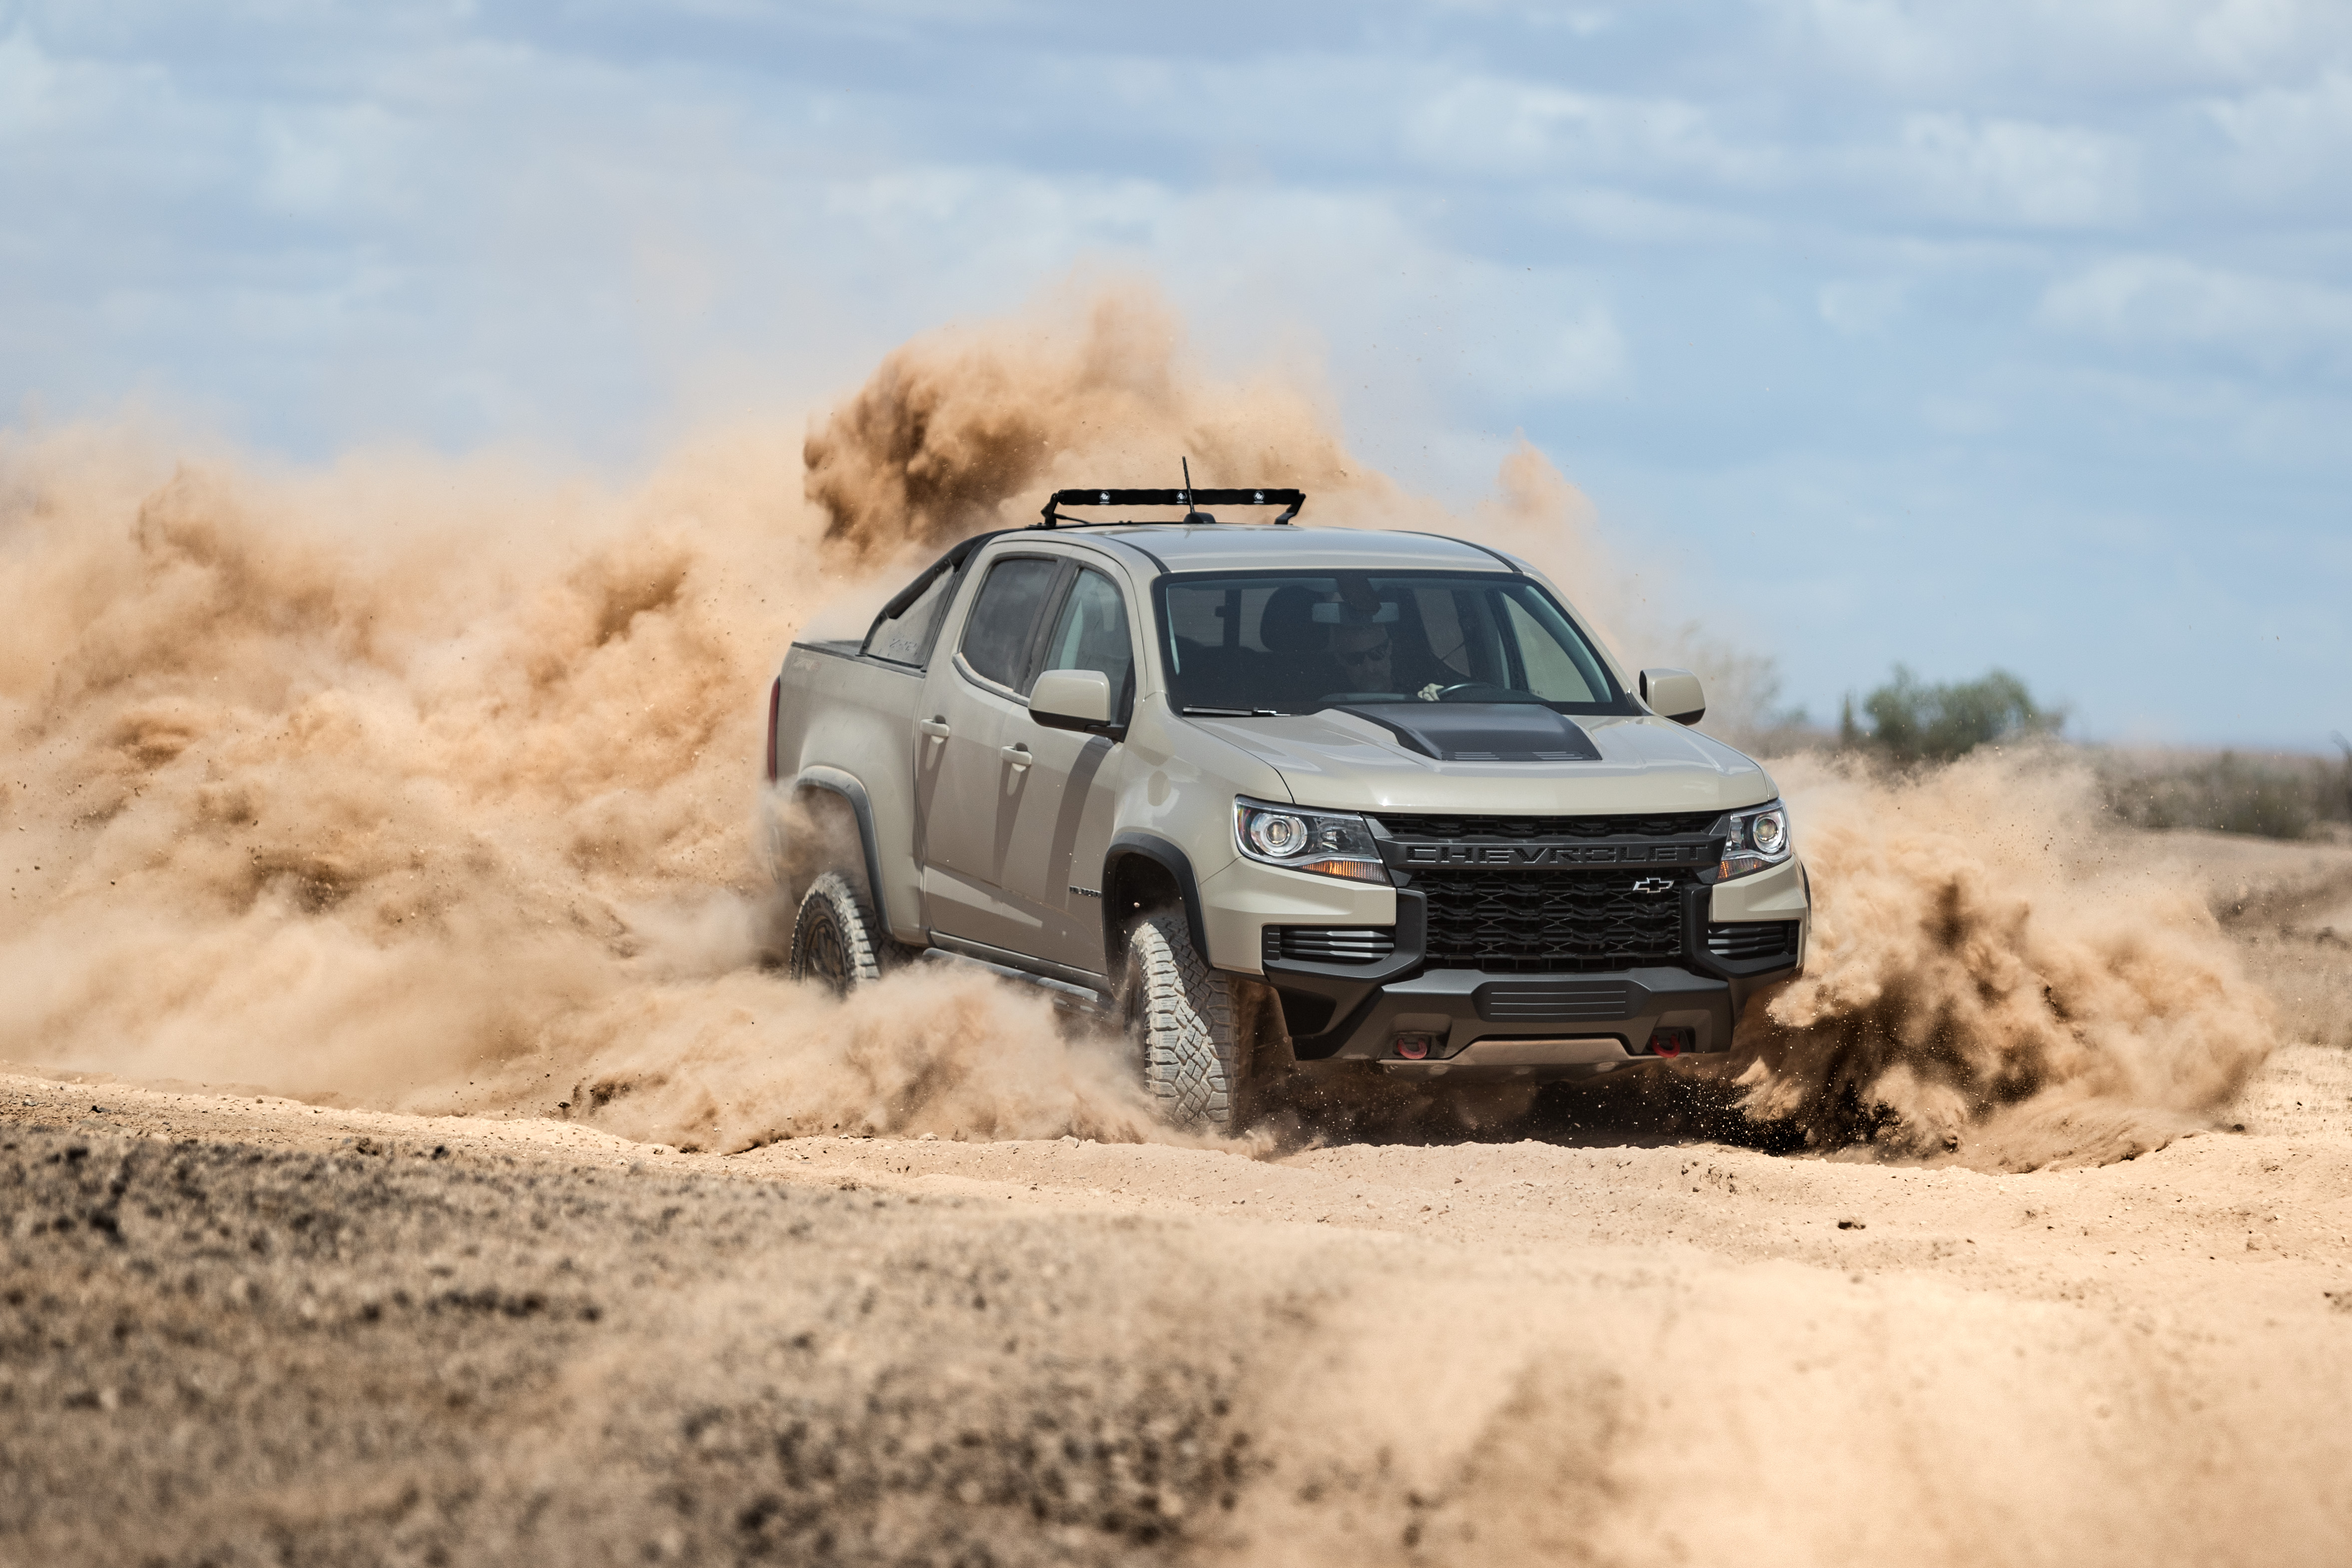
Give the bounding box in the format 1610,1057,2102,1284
0,294,1388,1147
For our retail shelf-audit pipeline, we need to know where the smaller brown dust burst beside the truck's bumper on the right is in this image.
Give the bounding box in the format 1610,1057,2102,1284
1736,748,2277,1168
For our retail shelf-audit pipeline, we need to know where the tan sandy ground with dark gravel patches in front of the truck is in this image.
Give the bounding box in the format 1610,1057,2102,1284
0,846,2352,1564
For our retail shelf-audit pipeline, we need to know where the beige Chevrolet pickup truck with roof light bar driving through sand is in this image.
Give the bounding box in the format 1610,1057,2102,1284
767,489,1811,1128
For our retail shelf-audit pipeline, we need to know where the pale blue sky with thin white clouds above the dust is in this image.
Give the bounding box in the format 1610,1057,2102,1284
0,0,2352,750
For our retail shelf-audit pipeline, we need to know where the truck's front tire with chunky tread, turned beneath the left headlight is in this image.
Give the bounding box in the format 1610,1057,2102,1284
1119,915,1247,1133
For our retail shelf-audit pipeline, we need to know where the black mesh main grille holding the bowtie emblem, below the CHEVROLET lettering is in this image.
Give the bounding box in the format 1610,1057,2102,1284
1413,868,1698,973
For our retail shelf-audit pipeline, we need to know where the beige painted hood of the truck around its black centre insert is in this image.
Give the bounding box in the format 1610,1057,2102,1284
1185,708,1776,816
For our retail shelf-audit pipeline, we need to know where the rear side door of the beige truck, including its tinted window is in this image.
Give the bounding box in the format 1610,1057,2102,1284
915,555,1075,955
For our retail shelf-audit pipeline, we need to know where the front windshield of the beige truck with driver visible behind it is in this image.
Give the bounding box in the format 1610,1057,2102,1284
1160,571,1639,715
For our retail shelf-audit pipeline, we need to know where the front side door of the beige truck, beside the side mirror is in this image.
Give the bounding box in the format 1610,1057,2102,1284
1002,566,1136,976
